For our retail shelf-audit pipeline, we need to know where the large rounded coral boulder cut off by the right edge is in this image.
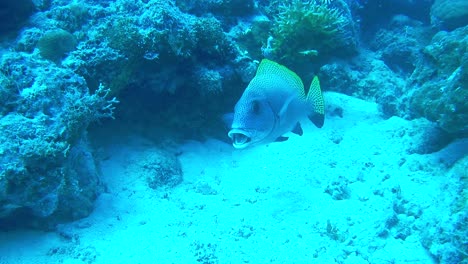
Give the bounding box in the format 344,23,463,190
410,26,468,135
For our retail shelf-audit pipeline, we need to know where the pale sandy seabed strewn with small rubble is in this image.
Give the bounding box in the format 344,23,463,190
0,93,464,264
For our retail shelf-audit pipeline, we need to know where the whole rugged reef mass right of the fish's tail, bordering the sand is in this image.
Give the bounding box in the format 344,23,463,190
319,11,468,136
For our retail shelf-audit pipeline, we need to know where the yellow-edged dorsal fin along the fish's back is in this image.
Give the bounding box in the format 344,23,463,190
256,59,305,98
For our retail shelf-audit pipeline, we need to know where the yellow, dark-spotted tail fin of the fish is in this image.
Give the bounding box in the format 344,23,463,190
307,76,325,128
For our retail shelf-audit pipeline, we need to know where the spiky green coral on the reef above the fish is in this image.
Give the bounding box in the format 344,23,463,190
271,0,349,64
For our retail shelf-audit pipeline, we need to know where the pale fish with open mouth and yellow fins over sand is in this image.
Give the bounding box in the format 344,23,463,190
228,59,324,149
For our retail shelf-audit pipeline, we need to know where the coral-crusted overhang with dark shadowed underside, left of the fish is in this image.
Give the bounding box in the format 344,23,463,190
48,0,244,138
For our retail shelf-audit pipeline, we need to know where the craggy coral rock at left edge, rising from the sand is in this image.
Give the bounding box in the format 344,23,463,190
0,52,116,228
